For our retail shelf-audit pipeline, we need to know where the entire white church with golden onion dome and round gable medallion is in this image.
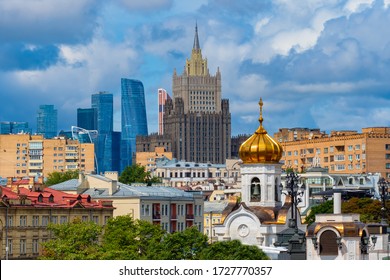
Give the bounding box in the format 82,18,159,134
215,99,306,259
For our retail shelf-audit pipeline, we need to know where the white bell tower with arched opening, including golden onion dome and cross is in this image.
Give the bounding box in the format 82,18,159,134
239,99,283,207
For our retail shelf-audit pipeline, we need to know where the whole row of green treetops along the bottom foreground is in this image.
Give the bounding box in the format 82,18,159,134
42,215,268,260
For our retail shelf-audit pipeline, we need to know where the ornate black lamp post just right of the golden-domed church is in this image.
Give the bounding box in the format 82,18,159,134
280,172,305,255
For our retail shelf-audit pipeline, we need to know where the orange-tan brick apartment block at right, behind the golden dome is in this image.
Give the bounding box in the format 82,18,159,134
276,127,390,178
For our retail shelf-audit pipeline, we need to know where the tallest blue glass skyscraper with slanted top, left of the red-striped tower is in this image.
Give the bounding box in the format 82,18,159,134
121,78,148,172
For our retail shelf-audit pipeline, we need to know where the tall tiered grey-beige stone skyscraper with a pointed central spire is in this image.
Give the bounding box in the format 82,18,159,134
164,26,231,163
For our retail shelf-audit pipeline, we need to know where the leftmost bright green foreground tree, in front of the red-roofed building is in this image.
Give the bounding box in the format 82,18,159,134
41,219,102,260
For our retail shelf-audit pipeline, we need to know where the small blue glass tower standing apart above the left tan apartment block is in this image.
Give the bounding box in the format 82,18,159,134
37,105,58,138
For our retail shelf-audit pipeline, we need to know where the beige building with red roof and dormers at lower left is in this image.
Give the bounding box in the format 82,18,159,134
0,178,114,260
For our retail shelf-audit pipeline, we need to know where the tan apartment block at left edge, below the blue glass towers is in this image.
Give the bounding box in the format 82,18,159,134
0,134,95,177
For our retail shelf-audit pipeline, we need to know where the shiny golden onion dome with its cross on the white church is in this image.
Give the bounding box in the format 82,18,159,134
238,98,283,163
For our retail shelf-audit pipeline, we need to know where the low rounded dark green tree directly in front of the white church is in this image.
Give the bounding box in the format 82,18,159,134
199,240,270,260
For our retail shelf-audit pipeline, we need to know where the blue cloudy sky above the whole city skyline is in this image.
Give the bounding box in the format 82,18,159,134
0,0,390,135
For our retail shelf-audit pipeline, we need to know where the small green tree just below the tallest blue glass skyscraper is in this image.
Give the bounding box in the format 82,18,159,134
119,164,161,185
